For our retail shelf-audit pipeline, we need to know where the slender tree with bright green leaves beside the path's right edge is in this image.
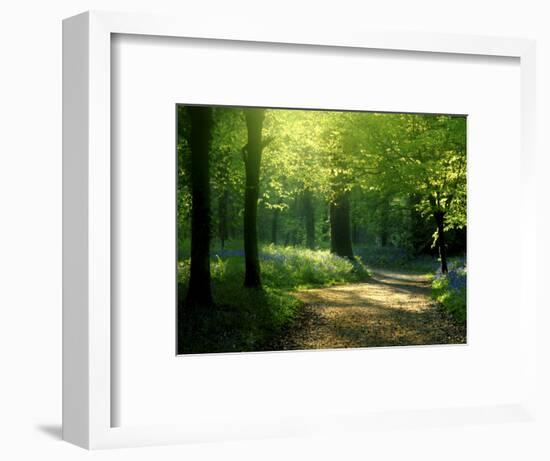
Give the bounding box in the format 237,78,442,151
369,114,466,273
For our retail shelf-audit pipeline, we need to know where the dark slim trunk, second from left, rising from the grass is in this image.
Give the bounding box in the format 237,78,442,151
243,109,265,288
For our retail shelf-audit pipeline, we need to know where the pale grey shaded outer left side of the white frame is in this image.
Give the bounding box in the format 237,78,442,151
62,13,90,448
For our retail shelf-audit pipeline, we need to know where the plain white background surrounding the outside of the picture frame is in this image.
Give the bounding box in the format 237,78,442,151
0,0,550,461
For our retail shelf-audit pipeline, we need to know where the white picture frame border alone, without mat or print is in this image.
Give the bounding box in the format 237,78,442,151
63,12,537,448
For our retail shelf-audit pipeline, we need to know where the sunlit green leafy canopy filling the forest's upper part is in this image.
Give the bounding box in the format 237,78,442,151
178,106,466,255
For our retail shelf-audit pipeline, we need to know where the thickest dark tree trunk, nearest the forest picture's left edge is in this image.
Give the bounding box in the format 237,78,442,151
186,106,212,310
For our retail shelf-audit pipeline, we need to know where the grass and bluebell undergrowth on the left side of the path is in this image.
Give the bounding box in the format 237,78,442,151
178,245,369,353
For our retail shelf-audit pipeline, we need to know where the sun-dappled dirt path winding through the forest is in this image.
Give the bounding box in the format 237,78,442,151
283,270,466,349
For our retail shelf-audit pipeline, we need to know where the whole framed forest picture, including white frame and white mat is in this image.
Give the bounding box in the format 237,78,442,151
63,12,537,448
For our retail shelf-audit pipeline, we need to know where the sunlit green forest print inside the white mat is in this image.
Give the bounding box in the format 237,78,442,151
176,104,467,354
